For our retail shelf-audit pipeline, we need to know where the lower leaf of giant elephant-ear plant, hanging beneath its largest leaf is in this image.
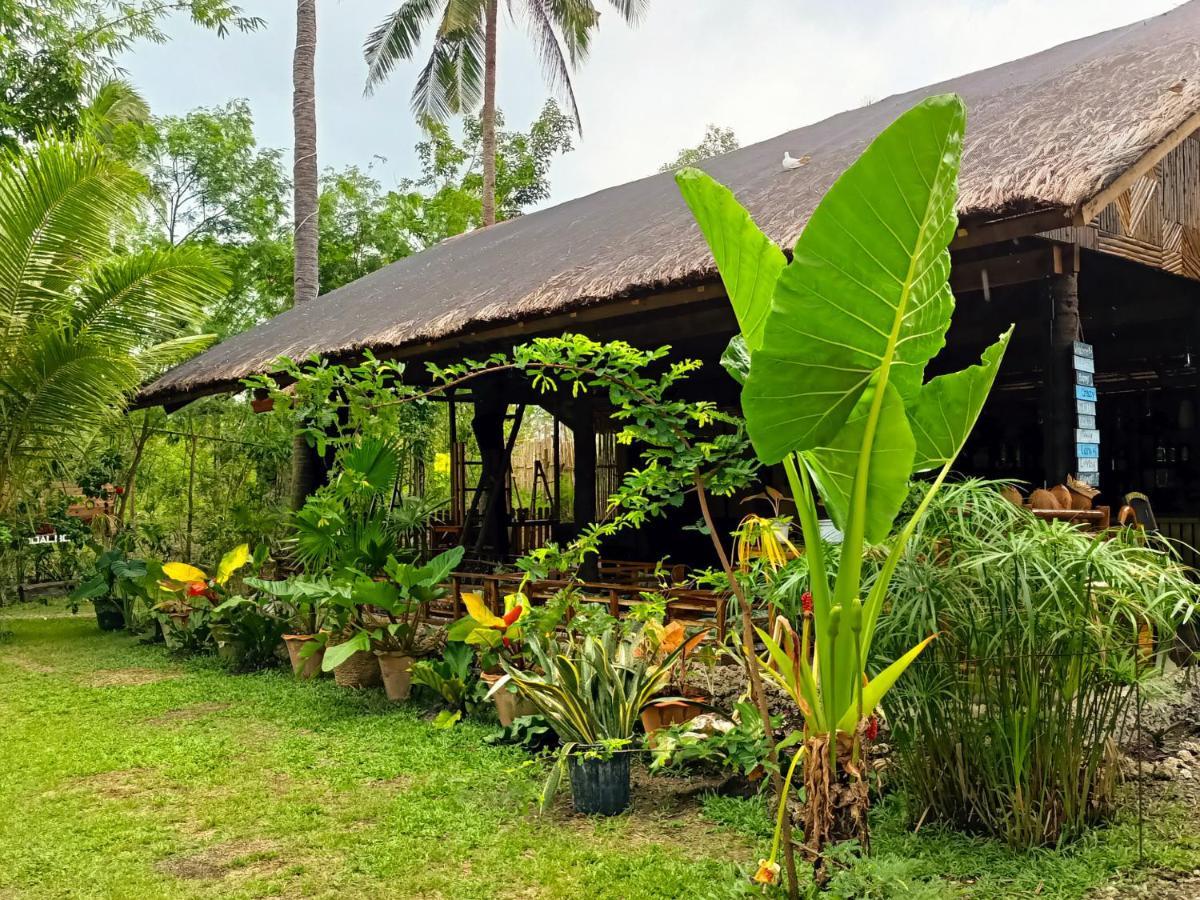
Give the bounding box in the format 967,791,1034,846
802,384,917,544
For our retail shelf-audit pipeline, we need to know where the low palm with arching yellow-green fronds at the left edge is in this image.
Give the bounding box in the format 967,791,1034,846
0,137,227,514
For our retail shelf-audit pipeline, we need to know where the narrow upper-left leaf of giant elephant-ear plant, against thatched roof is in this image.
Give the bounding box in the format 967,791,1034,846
676,168,787,350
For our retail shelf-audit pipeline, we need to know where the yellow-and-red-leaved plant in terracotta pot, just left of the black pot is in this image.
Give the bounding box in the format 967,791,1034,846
446,592,535,728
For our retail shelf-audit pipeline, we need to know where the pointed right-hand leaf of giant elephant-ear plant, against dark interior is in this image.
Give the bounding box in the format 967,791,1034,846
908,328,1013,472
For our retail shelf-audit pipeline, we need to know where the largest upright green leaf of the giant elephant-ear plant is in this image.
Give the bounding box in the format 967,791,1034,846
731,95,966,463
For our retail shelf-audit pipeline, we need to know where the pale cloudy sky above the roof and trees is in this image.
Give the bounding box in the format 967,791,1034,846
121,0,1178,203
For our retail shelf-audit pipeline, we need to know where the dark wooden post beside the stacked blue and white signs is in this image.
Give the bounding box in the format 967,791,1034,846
1042,272,1082,486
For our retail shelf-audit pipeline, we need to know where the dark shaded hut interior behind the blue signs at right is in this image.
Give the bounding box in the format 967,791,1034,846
936,243,1200,547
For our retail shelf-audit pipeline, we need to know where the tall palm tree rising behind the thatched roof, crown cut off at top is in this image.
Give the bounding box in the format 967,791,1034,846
364,0,649,226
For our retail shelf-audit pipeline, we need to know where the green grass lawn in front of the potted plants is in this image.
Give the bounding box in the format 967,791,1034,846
0,606,1200,899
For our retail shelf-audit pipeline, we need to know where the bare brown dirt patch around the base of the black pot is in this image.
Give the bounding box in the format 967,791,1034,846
552,766,751,862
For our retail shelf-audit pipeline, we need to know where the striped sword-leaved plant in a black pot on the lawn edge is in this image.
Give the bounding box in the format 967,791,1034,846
493,626,700,816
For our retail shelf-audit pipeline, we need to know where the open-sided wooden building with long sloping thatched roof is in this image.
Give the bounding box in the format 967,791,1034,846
140,0,1200,561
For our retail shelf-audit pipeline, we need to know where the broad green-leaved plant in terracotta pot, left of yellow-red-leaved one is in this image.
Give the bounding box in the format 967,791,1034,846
322,547,464,701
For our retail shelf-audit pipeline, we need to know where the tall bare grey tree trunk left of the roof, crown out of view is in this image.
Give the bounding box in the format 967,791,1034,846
292,0,323,509
